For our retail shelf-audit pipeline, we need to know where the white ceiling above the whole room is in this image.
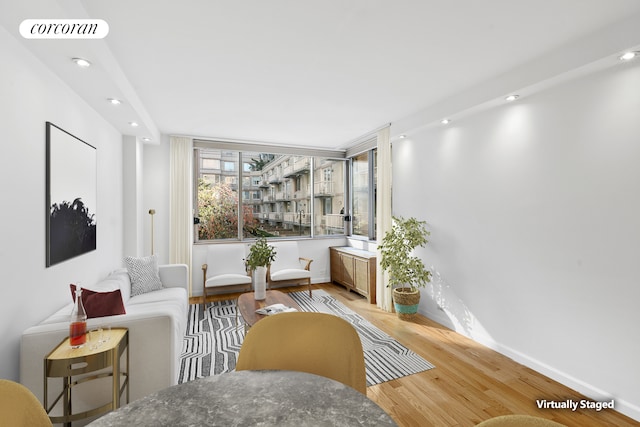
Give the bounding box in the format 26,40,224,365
0,0,640,149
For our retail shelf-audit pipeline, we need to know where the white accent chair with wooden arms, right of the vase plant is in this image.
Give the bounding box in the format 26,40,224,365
267,241,313,296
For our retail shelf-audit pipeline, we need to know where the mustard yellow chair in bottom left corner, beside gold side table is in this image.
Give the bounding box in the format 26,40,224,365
0,379,51,427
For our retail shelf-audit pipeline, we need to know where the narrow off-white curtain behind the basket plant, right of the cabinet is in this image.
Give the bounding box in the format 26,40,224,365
376,126,393,311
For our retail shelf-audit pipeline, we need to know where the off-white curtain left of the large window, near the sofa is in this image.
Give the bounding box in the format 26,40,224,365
169,136,193,295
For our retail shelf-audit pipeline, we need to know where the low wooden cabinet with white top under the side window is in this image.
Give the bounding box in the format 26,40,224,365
329,246,376,304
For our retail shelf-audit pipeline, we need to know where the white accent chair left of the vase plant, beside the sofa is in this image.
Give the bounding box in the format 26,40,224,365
202,243,251,308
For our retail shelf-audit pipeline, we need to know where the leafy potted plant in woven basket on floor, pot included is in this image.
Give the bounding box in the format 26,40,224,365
378,216,431,320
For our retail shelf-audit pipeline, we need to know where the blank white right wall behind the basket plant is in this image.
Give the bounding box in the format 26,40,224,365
392,63,640,419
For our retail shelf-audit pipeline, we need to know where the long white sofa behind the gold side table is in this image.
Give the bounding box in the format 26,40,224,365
20,264,189,422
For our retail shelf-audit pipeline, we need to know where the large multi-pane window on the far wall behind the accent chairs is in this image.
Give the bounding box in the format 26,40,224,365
195,148,347,241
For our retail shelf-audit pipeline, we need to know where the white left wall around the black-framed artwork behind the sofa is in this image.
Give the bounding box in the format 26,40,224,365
0,27,122,380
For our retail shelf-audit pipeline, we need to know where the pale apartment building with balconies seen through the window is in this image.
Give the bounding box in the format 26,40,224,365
197,149,348,239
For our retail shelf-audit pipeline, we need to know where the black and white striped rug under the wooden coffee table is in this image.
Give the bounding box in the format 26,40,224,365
178,289,434,386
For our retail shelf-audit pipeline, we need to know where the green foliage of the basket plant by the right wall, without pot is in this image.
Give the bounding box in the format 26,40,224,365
378,216,431,292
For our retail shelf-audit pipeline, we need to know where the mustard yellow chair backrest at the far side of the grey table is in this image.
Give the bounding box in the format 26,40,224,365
236,312,367,394
